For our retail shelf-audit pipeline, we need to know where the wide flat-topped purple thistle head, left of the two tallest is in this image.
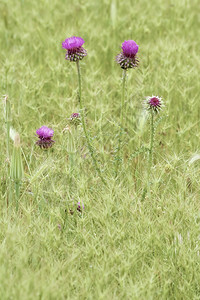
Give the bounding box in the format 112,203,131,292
62,36,87,62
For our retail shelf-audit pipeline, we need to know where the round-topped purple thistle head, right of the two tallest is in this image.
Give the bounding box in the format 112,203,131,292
116,40,139,70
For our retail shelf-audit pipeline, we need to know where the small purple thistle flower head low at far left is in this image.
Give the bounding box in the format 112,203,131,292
36,126,55,149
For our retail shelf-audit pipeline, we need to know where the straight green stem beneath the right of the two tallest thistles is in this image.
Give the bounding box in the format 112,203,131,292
115,69,126,177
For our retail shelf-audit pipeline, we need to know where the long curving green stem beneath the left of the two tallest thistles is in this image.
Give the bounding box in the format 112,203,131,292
76,60,107,185
